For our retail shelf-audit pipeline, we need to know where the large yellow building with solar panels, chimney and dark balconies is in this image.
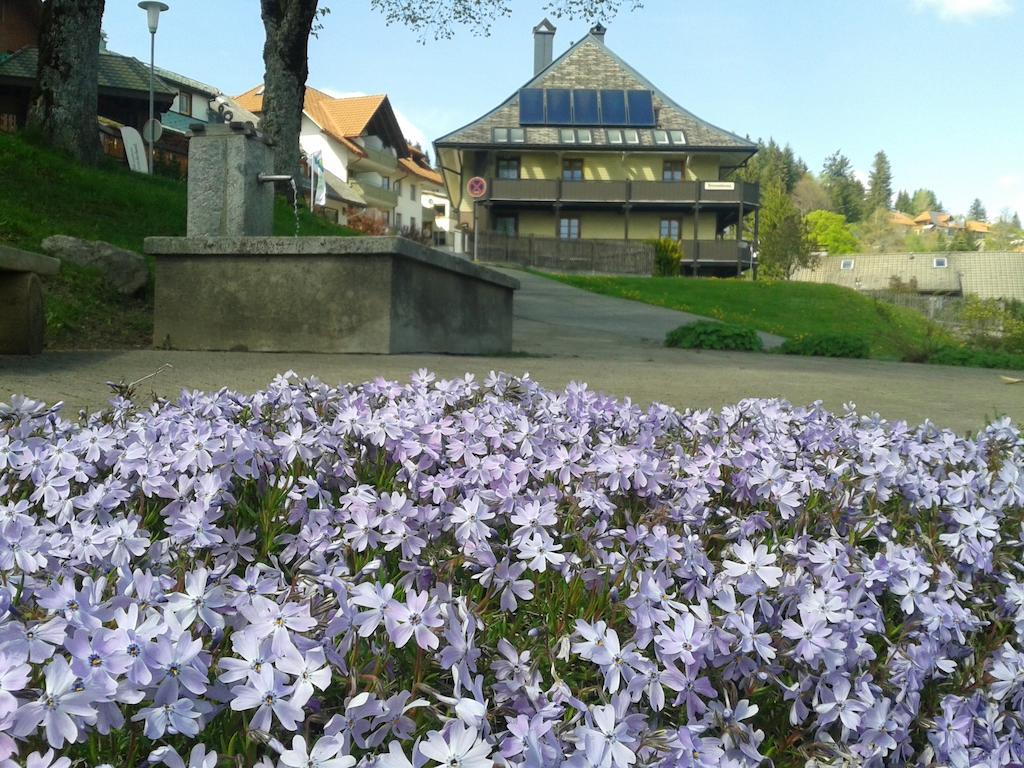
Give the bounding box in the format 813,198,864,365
435,19,760,274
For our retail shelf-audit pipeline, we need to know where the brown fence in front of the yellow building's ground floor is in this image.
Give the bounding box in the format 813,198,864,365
477,232,654,275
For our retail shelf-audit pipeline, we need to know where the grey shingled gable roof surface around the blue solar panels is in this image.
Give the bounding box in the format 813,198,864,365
435,35,757,155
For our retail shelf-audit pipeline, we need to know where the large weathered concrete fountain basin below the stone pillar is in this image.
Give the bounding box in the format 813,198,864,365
145,238,518,354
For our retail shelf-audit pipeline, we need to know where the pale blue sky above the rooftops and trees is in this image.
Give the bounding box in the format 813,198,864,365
97,0,1024,217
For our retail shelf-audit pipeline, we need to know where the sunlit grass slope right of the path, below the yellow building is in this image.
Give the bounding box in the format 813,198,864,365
546,274,940,358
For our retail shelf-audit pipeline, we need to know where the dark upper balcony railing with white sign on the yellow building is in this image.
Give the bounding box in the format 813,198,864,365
487,178,760,206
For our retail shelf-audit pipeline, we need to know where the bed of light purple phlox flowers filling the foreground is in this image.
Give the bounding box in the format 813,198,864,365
0,372,1024,768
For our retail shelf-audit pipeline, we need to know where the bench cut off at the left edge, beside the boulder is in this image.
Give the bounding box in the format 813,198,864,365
0,246,60,354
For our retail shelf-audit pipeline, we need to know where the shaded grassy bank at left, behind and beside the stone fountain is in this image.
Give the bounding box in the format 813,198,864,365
0,134,352,349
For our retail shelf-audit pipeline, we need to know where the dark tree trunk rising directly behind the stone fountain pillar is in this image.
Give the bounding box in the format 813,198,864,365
260,0,317,175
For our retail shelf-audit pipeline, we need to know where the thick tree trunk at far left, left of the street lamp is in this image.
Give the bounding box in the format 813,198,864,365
28,0,104,163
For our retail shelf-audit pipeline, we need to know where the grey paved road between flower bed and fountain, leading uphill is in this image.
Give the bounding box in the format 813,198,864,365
0,274,1024,432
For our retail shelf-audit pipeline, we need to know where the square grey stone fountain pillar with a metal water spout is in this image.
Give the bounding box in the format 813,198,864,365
187,123,274,238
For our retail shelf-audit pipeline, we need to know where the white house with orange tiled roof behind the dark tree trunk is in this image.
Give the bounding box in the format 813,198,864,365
233,85,420,228
